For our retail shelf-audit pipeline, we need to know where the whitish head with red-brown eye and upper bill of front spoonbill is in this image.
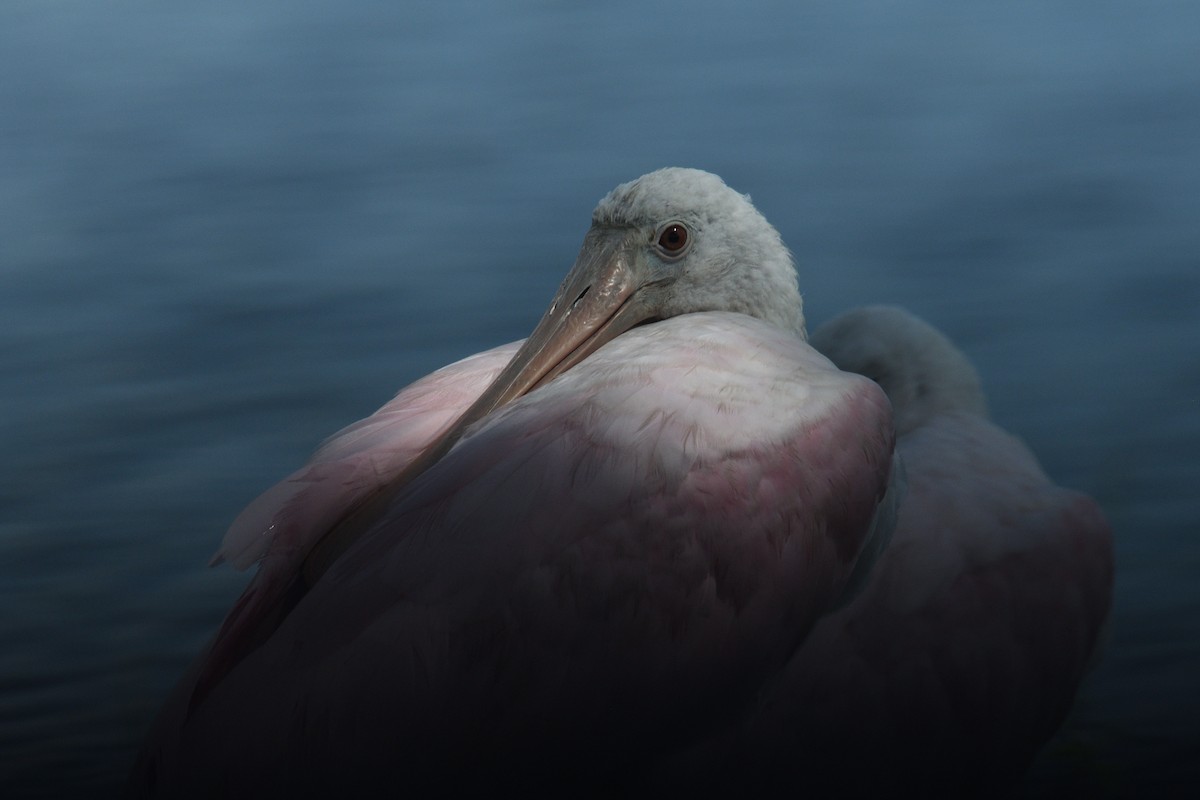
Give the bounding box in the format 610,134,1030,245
474,167,805,410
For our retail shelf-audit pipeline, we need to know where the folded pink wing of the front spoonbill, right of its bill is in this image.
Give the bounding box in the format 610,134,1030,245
133,313,893,793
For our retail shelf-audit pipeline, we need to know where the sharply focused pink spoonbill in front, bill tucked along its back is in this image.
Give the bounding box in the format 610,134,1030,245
131,169,1108,796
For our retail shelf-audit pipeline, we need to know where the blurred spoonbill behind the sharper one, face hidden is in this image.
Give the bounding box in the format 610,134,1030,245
664,306,1114,798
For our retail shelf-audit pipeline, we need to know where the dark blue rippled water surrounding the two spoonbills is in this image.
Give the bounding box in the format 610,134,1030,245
0,0,1200,798
